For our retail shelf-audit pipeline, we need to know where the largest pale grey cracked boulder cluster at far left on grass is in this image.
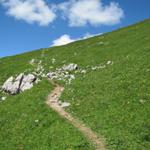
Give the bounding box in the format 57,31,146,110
2,73,36,95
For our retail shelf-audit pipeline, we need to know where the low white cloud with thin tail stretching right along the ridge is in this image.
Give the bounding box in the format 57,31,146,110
52,33,102,46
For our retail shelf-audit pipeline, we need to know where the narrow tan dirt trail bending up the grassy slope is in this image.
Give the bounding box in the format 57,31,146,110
46,85,106,150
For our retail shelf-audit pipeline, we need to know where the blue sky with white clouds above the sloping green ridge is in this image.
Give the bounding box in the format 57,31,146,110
0,0,150,57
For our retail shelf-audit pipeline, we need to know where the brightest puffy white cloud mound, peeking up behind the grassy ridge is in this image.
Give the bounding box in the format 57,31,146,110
52,34,75,46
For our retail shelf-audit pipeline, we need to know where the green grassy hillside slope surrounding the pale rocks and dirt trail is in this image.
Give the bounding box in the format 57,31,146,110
0,20,150,150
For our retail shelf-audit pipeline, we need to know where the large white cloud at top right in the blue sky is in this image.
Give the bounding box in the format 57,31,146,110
58,0,124,26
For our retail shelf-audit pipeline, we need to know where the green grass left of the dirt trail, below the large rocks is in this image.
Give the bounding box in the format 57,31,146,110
0,81,93,150
